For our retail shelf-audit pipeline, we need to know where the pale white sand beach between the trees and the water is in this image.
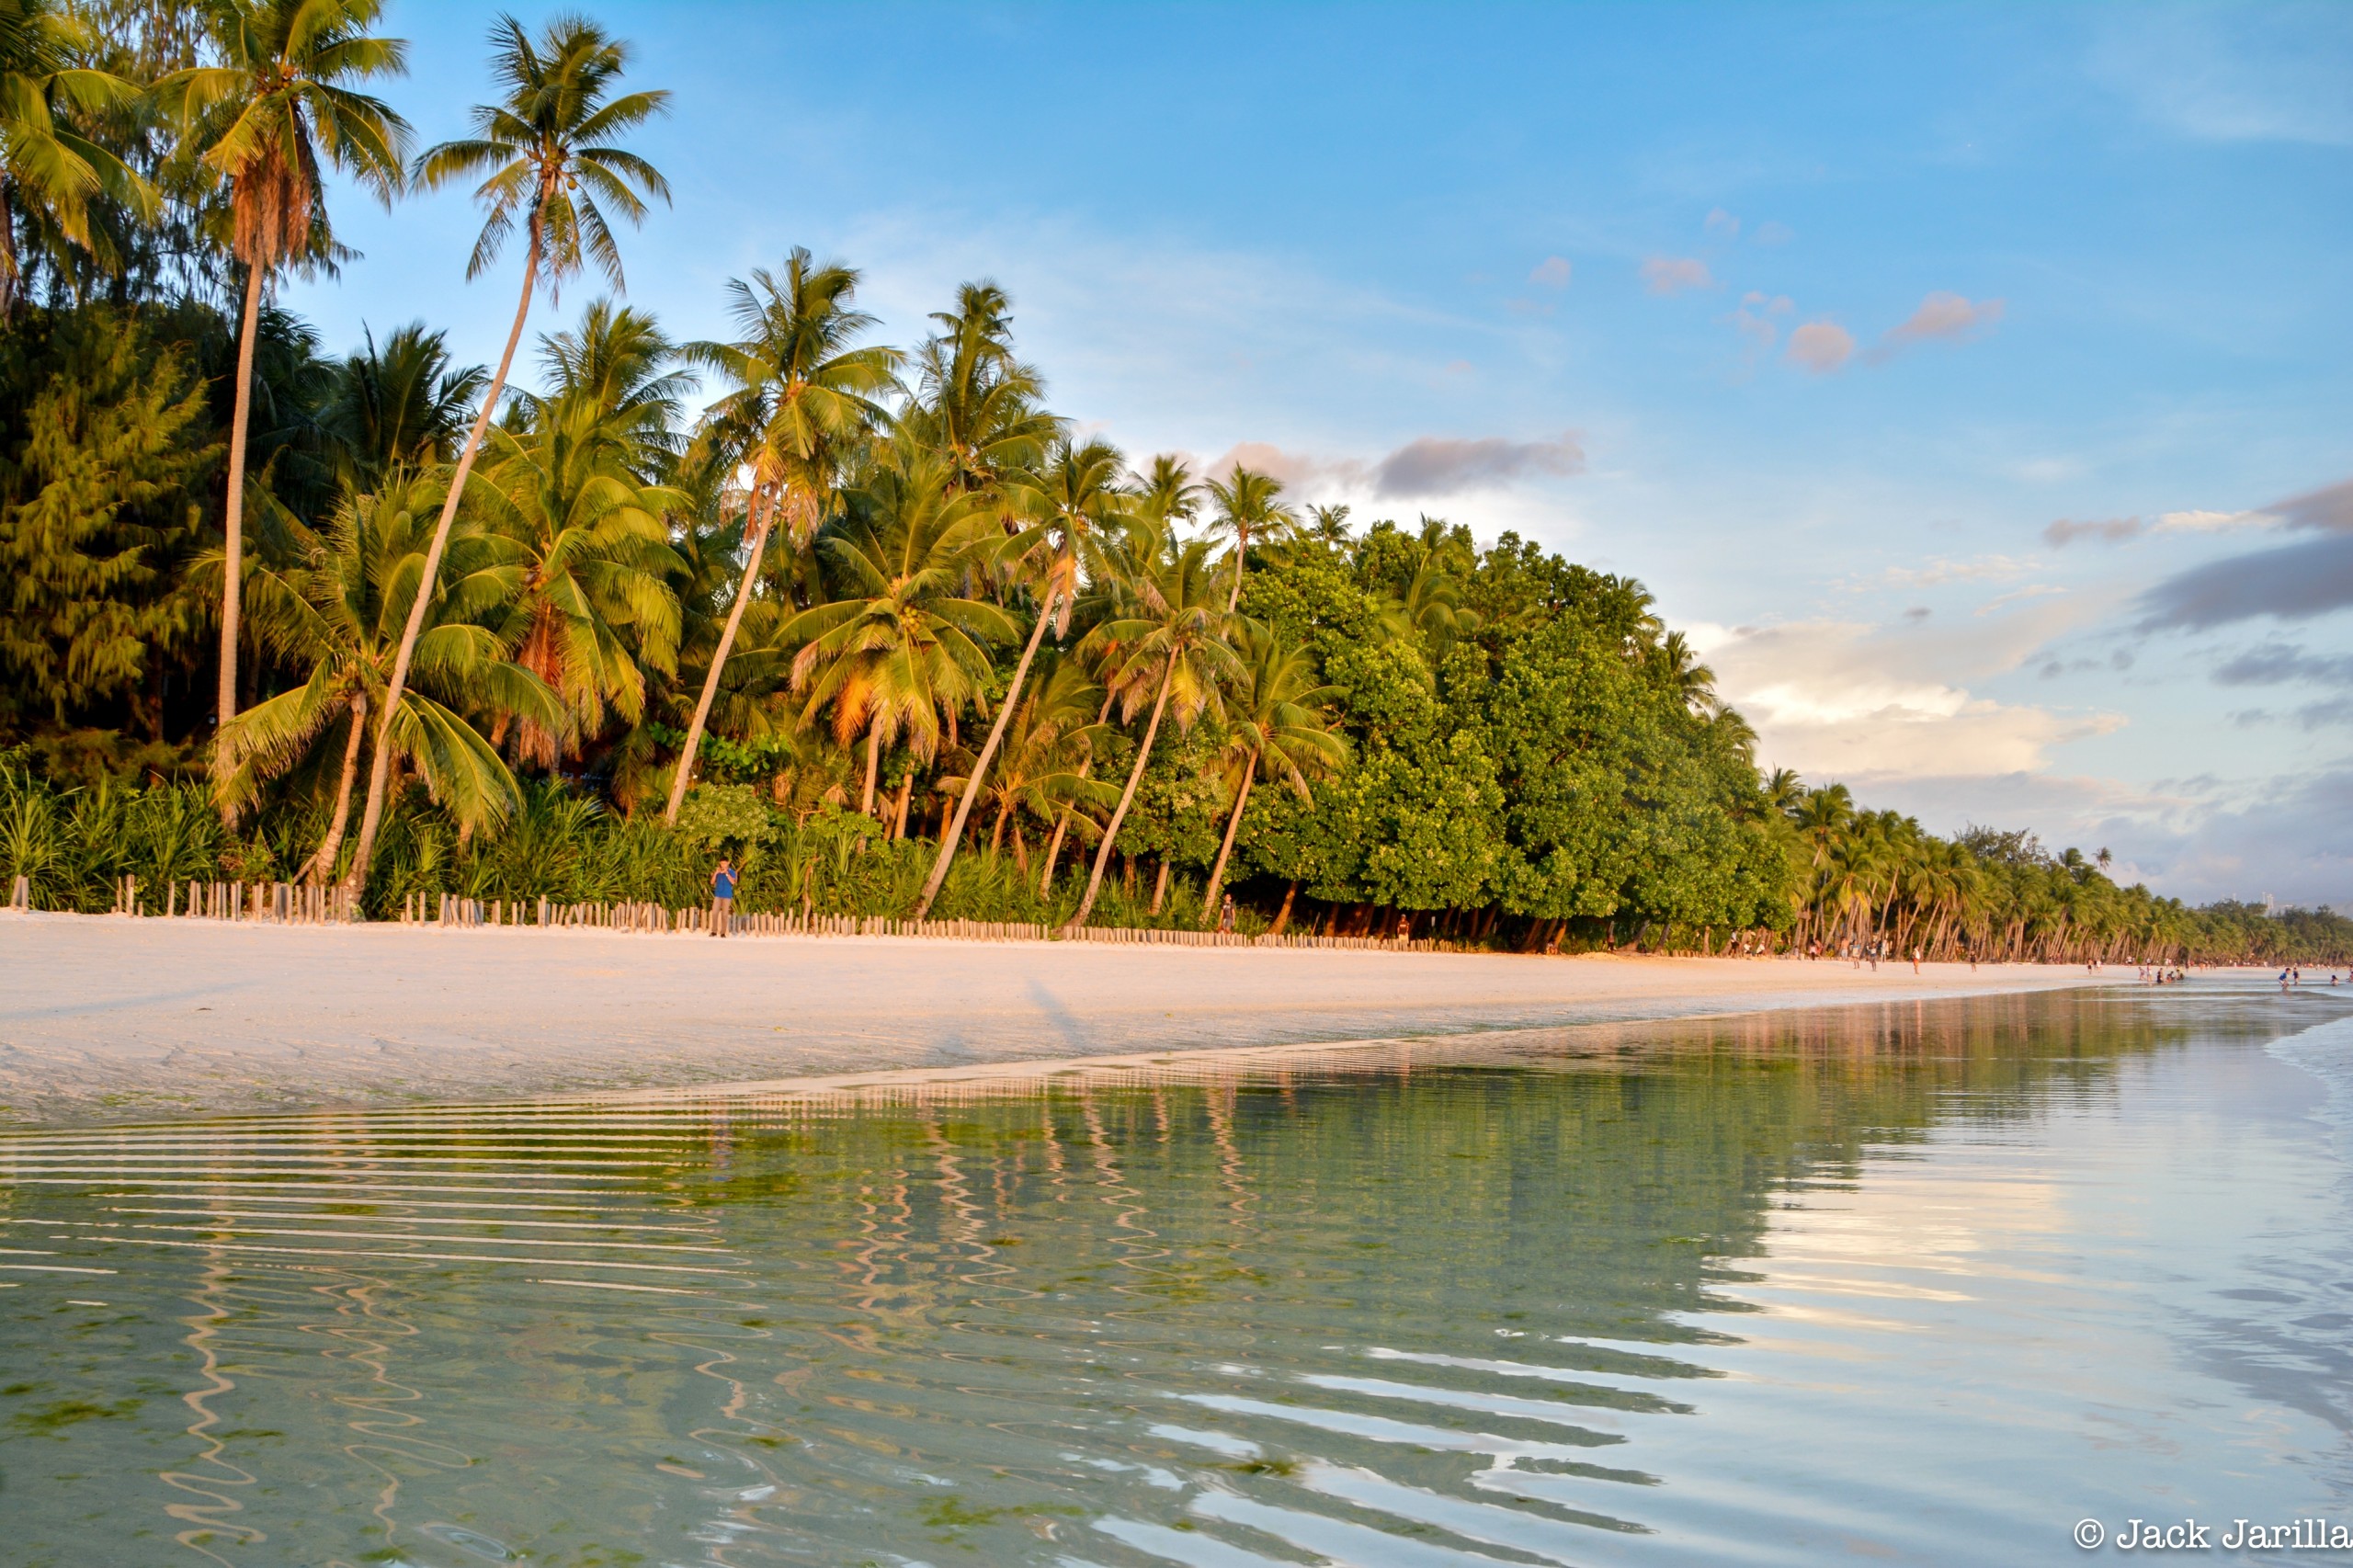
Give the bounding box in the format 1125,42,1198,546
0,914,2130,1125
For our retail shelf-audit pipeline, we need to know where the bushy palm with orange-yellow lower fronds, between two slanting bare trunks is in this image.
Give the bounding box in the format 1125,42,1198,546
779,431,1014,814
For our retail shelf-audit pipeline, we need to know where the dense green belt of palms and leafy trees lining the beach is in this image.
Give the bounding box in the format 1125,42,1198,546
0,0,2353,963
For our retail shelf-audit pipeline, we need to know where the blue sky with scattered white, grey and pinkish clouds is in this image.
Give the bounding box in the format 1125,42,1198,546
285,0,2353,909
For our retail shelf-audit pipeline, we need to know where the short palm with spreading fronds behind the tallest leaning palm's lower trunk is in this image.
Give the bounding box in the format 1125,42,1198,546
217,475,555,883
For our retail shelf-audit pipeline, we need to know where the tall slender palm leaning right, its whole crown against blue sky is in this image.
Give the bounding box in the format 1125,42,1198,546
339,0,671,888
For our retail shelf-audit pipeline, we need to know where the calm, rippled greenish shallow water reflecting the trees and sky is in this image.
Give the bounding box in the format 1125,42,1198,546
0,982,2353,1568
